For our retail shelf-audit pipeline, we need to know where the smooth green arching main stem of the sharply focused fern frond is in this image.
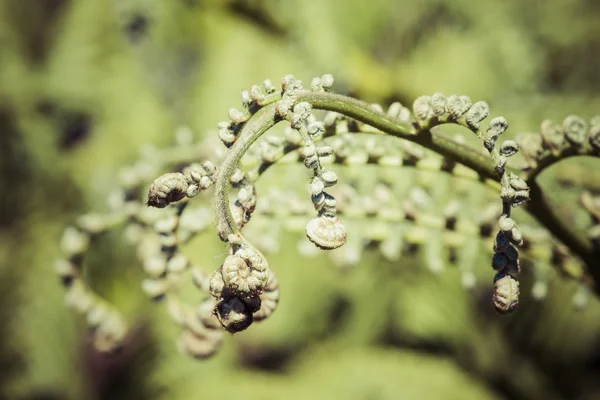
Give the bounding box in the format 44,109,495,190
215,92,600,287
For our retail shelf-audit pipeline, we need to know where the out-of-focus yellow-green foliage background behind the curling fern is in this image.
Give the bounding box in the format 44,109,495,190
0,0,600,400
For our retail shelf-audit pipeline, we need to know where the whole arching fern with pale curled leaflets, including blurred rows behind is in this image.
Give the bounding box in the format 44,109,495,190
56,74,600,358
